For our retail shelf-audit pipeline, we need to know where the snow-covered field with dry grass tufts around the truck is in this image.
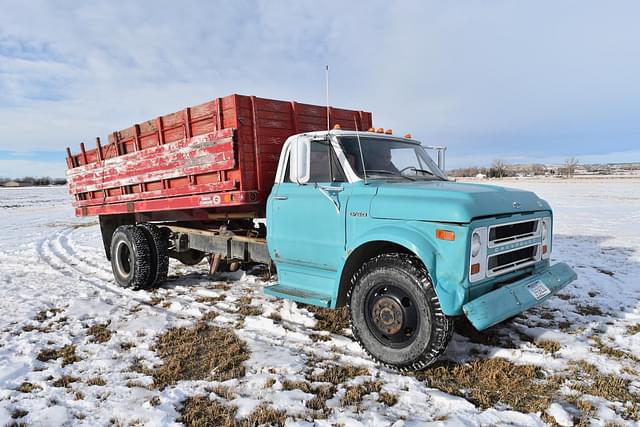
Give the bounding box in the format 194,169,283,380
0,180,640,426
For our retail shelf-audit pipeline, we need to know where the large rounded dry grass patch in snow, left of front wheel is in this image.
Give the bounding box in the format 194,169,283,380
144,322,249,388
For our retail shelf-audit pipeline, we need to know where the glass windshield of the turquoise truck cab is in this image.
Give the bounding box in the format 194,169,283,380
339,136,447,180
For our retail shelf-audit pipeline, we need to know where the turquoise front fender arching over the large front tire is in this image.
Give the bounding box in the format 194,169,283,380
341,221,468,316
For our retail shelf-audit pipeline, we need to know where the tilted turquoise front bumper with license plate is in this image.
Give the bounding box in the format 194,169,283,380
462,262,578,331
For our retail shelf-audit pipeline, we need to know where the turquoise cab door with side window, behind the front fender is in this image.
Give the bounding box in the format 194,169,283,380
268,141,349,271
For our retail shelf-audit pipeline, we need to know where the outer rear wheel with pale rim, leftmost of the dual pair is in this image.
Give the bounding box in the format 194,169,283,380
110,225,152,289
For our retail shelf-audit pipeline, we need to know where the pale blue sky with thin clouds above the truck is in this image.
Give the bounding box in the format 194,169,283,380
0,0,640,177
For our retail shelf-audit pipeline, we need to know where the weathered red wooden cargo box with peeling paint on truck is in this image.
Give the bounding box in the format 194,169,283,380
67,95,372,219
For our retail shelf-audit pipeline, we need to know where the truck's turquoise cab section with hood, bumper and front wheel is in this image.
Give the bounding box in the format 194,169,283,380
265,130,576,370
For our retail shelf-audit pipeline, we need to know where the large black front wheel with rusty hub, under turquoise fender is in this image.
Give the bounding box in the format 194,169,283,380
347,253,453,372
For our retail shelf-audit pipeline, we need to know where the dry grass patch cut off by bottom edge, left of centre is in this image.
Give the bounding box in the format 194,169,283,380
178,396,286,427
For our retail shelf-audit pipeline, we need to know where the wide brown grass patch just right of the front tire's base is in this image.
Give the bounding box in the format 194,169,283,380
415,358,559,412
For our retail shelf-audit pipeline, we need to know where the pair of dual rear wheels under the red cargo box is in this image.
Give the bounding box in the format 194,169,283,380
110,223,169,289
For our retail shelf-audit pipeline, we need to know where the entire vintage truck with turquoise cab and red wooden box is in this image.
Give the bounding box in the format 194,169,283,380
67,95,576,370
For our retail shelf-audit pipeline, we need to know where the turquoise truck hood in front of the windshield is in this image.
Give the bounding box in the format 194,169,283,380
369,181,551,223
